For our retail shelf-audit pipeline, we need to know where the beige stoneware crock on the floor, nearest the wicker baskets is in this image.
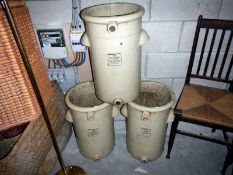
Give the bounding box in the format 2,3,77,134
65,82,118,160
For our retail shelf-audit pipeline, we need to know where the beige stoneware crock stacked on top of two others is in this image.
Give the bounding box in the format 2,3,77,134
81,3,149,104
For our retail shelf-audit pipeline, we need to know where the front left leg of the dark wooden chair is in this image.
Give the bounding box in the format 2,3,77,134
166,117,179,159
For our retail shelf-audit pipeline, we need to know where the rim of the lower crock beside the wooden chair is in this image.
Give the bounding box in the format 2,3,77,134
128,81,175,112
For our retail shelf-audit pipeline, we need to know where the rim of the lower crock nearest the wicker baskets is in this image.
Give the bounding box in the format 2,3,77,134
65,81,110,112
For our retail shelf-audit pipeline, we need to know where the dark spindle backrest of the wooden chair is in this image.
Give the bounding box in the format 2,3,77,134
185,15,233,91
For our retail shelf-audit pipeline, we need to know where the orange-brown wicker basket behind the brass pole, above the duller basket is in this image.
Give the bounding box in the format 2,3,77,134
0,5,53,131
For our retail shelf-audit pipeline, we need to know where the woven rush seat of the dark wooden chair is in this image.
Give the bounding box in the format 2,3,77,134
176,84,233,128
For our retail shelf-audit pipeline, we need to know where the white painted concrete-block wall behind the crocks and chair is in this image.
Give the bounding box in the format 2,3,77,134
27,0,233,102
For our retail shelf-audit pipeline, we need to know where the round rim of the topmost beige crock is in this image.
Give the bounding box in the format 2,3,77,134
81,2,145,24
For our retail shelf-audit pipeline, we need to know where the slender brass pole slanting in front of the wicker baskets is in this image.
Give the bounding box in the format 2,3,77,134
0,0,67,175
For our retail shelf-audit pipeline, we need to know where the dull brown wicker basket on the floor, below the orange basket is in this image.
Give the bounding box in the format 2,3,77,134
0,84,72,175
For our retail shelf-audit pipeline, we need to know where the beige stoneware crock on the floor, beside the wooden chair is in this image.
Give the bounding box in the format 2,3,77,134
121,81,174,162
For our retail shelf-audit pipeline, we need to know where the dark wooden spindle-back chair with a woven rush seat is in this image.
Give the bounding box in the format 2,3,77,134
166,16,233,173
